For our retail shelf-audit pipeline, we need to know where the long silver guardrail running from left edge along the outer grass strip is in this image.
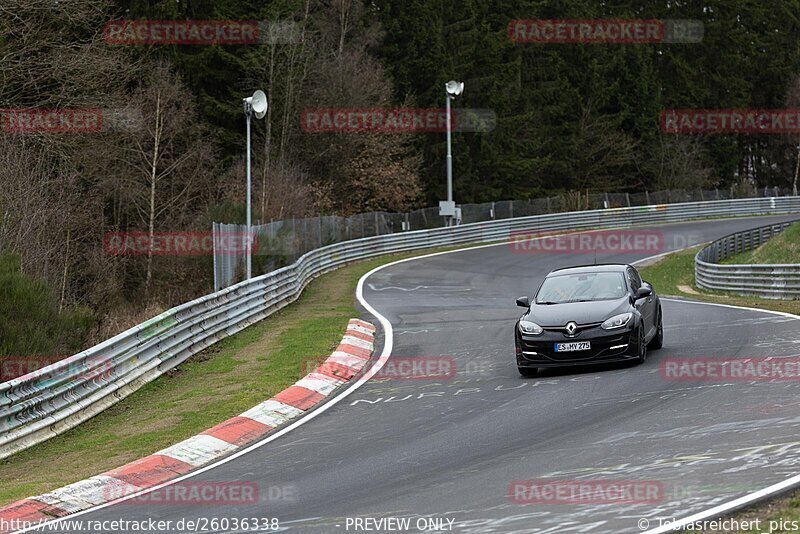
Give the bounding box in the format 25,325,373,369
0,197,800,458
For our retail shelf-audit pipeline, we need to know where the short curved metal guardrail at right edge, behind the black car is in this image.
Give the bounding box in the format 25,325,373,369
694,222,800,299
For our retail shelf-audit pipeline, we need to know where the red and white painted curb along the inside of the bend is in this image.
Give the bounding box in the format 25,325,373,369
0,319,375,532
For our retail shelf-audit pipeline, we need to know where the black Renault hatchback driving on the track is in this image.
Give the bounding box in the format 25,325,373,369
514,264,664,376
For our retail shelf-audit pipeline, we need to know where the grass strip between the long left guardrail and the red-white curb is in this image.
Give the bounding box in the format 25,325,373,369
0,247,455,506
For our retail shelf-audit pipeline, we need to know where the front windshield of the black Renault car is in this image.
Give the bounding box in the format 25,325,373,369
536,272,627,304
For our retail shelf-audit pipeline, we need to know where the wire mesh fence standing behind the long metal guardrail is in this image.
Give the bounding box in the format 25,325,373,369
213,187,791,291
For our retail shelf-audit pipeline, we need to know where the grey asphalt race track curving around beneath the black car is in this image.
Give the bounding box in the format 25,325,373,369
32,216,800,533
